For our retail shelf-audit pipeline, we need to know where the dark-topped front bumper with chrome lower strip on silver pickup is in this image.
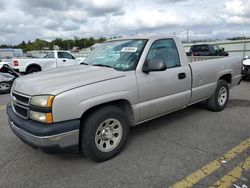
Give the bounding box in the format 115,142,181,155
6,104,80,153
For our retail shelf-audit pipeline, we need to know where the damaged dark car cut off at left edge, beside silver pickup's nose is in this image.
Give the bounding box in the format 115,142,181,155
0,64,20,94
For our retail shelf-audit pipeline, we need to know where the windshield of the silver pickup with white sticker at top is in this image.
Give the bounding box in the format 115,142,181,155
84,39,147,71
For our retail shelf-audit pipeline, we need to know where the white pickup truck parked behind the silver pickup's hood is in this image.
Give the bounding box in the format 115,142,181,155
11,50,81,74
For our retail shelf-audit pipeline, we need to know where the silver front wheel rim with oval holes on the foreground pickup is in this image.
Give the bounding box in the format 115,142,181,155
95,118,123,152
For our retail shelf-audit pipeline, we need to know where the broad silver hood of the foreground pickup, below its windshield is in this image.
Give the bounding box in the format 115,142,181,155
13,65,125,95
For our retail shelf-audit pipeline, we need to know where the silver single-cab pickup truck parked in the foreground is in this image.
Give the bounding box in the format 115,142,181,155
7,36,241,162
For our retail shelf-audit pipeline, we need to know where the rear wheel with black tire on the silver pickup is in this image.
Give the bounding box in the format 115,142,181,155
207,80,229,112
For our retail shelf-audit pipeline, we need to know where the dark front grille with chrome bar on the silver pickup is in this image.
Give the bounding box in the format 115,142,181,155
11,91,30,119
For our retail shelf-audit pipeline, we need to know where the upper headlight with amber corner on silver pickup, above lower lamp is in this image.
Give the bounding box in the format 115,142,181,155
30,95,54,108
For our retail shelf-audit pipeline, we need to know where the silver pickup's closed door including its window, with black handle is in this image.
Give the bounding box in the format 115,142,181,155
137,39,191,121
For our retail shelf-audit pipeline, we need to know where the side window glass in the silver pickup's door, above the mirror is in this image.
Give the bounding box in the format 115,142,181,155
146,39,180,68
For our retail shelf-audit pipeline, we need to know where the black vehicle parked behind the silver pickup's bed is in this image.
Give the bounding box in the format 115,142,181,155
187,44,228,56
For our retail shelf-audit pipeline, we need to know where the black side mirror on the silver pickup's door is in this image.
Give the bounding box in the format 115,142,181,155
142,59,167,73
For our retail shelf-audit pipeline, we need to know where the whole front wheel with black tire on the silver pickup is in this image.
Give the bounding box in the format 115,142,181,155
80,106,129,162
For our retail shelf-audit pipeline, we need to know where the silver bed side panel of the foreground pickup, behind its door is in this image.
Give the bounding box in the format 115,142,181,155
189,57,241,104
